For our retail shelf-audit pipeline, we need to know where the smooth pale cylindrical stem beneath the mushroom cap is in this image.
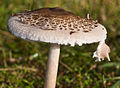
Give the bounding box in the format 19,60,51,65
44,44,60,88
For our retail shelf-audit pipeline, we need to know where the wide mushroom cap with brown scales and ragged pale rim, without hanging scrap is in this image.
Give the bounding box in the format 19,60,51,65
8,7,107,46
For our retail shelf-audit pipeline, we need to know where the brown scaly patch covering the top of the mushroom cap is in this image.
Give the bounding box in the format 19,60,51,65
12,7,98,32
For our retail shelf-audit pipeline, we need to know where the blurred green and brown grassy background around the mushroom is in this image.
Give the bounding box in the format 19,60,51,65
0,0,120,88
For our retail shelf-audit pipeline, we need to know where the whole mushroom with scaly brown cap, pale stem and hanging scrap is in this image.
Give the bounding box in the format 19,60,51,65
8,7,110,88
